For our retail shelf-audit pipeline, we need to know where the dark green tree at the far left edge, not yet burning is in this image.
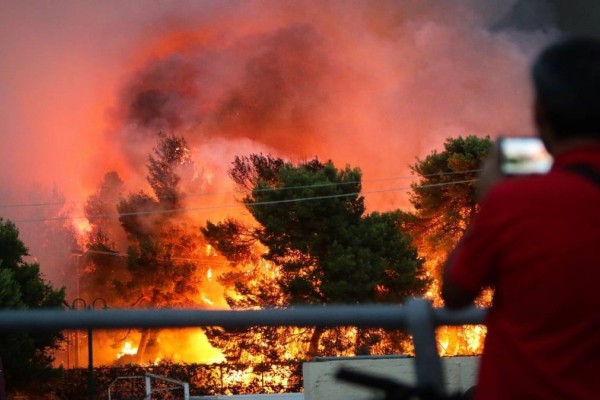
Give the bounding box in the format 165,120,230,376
0,218,65,390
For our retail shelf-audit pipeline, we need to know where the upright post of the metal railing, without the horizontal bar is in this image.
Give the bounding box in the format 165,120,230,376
406,299,446,395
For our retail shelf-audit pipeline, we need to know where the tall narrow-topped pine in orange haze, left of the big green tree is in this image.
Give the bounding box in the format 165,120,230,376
114,134,205,362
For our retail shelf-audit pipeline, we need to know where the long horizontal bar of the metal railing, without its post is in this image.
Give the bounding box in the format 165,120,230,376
0,305,486,331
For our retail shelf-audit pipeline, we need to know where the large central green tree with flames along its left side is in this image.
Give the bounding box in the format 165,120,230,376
202,154,428,359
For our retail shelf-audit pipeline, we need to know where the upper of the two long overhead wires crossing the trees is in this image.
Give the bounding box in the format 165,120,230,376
0,169,481,208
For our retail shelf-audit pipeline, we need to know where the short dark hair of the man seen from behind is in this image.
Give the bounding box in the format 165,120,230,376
532,37,600,140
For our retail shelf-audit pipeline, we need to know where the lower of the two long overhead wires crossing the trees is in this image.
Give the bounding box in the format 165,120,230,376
13,179,477,223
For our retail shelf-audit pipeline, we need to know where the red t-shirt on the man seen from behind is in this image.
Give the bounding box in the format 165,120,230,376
449,147,600,400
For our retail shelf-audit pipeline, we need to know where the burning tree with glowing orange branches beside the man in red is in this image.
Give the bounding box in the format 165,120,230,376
406,136,492,355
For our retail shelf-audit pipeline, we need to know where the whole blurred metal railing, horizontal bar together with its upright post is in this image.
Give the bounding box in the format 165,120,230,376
0,299,486,394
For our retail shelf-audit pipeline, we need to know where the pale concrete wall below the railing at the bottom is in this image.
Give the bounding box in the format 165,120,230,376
303,357,479,400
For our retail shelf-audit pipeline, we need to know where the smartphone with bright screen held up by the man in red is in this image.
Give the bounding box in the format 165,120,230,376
498,136,553,175
